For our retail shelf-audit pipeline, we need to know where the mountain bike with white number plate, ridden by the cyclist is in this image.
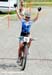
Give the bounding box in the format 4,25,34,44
17,37,34,71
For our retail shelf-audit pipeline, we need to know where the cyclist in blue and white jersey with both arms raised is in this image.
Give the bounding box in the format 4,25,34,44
16,8,41,62
